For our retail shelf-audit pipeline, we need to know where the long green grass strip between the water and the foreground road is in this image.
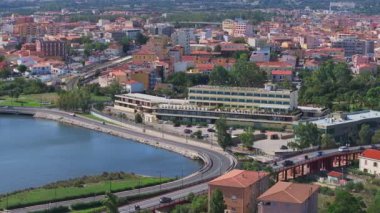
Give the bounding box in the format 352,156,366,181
0,176,171,209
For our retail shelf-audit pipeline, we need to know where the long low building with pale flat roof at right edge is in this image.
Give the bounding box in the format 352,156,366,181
306,110,380,142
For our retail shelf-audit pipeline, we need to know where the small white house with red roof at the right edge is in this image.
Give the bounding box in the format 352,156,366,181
359,149,380,176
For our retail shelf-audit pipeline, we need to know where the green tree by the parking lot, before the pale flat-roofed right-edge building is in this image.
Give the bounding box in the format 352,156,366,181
289,122,321,150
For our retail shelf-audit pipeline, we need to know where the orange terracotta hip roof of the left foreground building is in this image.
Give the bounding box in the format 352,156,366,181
209,169,268,188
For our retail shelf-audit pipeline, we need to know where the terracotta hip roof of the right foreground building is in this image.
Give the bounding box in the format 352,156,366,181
258,182,319,203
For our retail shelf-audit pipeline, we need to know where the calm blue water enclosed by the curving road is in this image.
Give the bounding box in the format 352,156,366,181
0,115,201,194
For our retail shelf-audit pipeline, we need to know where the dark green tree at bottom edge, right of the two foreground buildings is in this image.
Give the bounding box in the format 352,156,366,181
327,189,366,213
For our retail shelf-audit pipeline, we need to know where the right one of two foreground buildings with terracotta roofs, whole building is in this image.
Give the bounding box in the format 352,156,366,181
258,182,319,213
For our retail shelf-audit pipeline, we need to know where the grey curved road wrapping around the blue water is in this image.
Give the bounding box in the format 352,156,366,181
0,107,236,212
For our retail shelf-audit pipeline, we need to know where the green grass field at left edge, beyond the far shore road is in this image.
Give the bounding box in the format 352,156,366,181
0,93,58,107
